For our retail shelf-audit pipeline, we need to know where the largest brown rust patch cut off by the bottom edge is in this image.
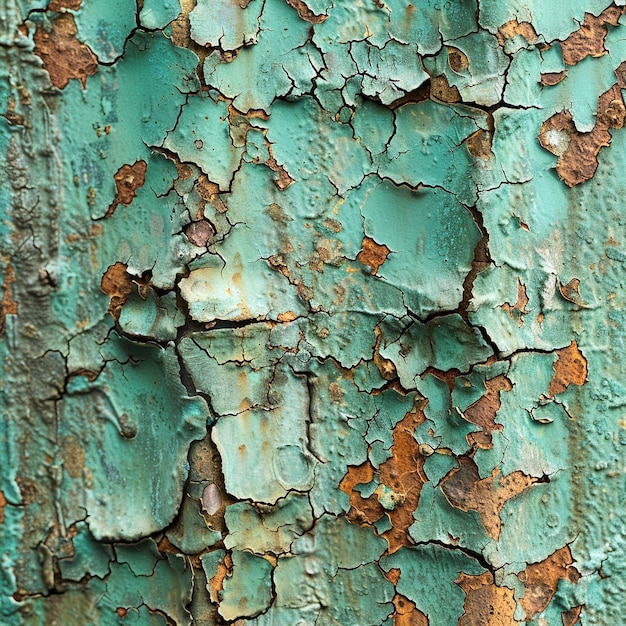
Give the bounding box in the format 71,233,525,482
455,572,520,626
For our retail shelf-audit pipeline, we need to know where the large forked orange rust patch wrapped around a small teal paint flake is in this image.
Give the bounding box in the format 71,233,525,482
339,406,428,553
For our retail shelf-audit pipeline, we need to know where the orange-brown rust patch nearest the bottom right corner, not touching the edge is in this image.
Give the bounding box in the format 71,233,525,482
517,546,580,623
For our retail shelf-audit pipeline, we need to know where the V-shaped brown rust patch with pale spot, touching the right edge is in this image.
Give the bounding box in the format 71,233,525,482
538,85,626,187
